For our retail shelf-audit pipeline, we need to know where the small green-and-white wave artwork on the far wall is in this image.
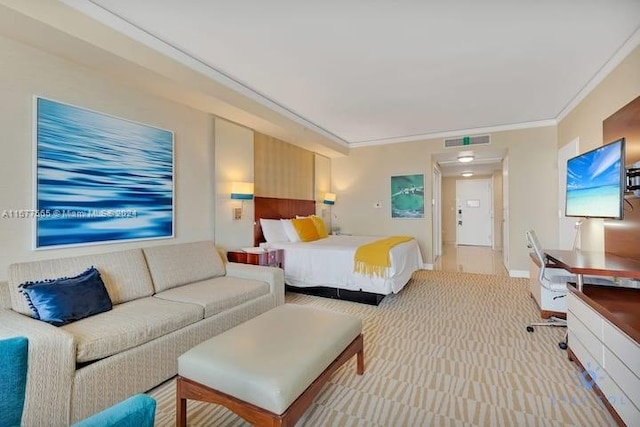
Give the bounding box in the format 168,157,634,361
391,174,424,218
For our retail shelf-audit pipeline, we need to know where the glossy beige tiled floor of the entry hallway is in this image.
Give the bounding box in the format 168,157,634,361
433,244,509,276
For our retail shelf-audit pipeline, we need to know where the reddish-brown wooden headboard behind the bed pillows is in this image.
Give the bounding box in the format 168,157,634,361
253,197,316,246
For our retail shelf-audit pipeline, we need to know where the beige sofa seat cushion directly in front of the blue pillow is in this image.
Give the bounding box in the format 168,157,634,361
61,297,203,362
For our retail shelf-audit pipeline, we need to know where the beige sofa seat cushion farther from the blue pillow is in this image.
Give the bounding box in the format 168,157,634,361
154,276,269,317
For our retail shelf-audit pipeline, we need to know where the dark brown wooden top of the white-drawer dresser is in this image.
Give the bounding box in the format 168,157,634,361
567,285,640,343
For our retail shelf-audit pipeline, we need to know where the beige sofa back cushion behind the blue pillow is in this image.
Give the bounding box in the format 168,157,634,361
9,249,153,316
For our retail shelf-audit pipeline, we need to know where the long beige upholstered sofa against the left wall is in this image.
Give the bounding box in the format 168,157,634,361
0,241,284,426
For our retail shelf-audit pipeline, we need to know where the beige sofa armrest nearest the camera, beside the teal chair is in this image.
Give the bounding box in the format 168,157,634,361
0,309,76,426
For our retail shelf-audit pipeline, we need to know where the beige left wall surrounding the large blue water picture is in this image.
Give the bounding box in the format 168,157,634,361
0,37,213,280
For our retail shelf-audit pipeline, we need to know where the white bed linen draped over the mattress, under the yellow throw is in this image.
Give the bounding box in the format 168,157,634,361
269,235,422,295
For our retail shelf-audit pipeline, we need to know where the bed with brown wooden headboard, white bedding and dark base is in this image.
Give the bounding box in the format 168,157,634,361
254,197,422,305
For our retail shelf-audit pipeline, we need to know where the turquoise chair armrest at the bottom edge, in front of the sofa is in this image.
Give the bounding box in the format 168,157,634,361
72,394,156,427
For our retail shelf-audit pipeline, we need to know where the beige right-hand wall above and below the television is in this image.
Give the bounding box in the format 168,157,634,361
558,46,640,250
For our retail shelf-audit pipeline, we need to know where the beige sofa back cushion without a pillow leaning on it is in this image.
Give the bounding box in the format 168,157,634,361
143,241,225,292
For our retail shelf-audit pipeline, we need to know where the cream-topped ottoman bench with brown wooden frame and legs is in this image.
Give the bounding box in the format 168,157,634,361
176,304,364,426
